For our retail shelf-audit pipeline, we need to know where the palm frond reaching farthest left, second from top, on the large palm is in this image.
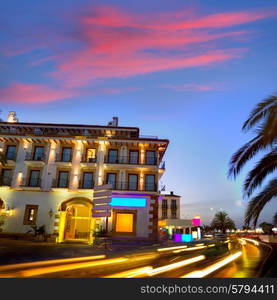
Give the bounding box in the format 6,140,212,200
228,135,268,178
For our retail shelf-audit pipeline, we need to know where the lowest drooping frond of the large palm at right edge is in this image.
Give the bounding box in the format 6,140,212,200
245,178,277,226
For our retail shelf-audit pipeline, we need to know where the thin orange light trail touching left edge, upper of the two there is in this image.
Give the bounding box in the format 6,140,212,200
0,255,106,272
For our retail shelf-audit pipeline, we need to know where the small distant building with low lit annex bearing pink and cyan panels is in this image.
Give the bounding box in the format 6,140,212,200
158,191,201,242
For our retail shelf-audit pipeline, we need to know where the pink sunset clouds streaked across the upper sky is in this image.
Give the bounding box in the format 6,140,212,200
0,6,276,103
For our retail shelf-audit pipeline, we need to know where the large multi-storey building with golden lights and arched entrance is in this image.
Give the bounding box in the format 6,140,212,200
0,112,169,242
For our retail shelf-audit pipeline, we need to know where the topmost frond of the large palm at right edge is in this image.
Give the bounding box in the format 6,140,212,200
242,95,277,131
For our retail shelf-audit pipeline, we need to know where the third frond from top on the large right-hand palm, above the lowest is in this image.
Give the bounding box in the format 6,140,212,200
243,149,277,197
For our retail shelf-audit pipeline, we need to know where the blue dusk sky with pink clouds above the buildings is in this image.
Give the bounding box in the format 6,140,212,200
0,0,277,226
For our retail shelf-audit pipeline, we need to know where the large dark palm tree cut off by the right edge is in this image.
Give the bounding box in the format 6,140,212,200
229,94,277,226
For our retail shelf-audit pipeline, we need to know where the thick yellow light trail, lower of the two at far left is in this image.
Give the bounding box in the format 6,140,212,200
13,257,129,277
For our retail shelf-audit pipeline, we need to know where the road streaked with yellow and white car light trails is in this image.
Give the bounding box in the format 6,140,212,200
0,239,271,278
